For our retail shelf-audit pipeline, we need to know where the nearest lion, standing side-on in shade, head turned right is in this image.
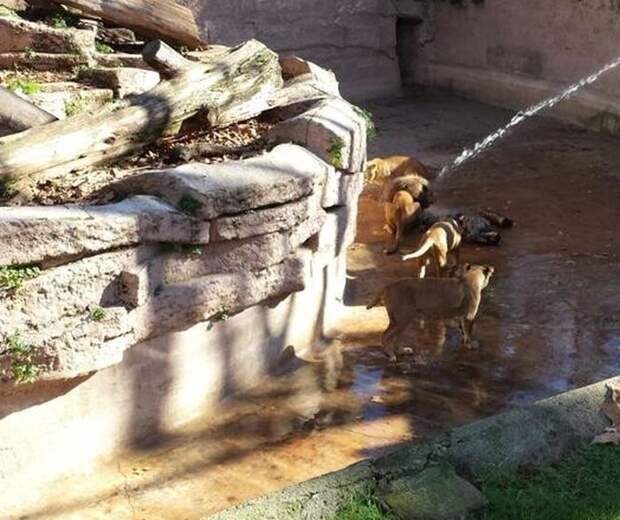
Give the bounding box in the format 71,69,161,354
366,264,494,361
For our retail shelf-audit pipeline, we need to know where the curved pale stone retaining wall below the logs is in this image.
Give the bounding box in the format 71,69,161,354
0,62,366,517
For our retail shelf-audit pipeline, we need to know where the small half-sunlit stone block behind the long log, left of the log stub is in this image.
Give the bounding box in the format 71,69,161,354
79,67,160,98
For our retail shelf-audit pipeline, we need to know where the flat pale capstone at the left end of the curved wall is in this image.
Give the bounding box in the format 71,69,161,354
0,196,200,266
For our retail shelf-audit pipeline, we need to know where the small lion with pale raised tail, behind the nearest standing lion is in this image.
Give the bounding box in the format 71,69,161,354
403,218,463,278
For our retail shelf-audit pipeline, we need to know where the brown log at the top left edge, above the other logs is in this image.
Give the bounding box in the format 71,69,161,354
51,0,204,48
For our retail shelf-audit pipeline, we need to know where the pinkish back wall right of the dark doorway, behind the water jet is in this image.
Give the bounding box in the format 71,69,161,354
399,0,620,133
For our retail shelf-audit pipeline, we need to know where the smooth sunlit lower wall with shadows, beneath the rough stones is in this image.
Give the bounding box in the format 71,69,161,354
0,246,355,518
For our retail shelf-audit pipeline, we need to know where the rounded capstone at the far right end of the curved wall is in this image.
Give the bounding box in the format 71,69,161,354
268,98,366,172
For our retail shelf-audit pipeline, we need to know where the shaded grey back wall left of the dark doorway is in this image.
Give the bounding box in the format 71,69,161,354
180,0,400,100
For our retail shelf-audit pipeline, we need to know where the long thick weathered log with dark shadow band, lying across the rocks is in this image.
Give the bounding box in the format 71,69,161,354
0,40,282,190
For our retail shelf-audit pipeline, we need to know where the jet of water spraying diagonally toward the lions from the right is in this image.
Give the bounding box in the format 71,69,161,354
437,56,620,180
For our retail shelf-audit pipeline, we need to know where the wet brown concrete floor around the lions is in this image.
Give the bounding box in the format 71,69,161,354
26,92,620,520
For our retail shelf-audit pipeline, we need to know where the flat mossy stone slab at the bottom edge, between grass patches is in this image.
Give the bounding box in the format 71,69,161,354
379,466,486,520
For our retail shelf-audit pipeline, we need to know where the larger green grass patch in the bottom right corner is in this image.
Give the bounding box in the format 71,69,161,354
474,445,620,520
